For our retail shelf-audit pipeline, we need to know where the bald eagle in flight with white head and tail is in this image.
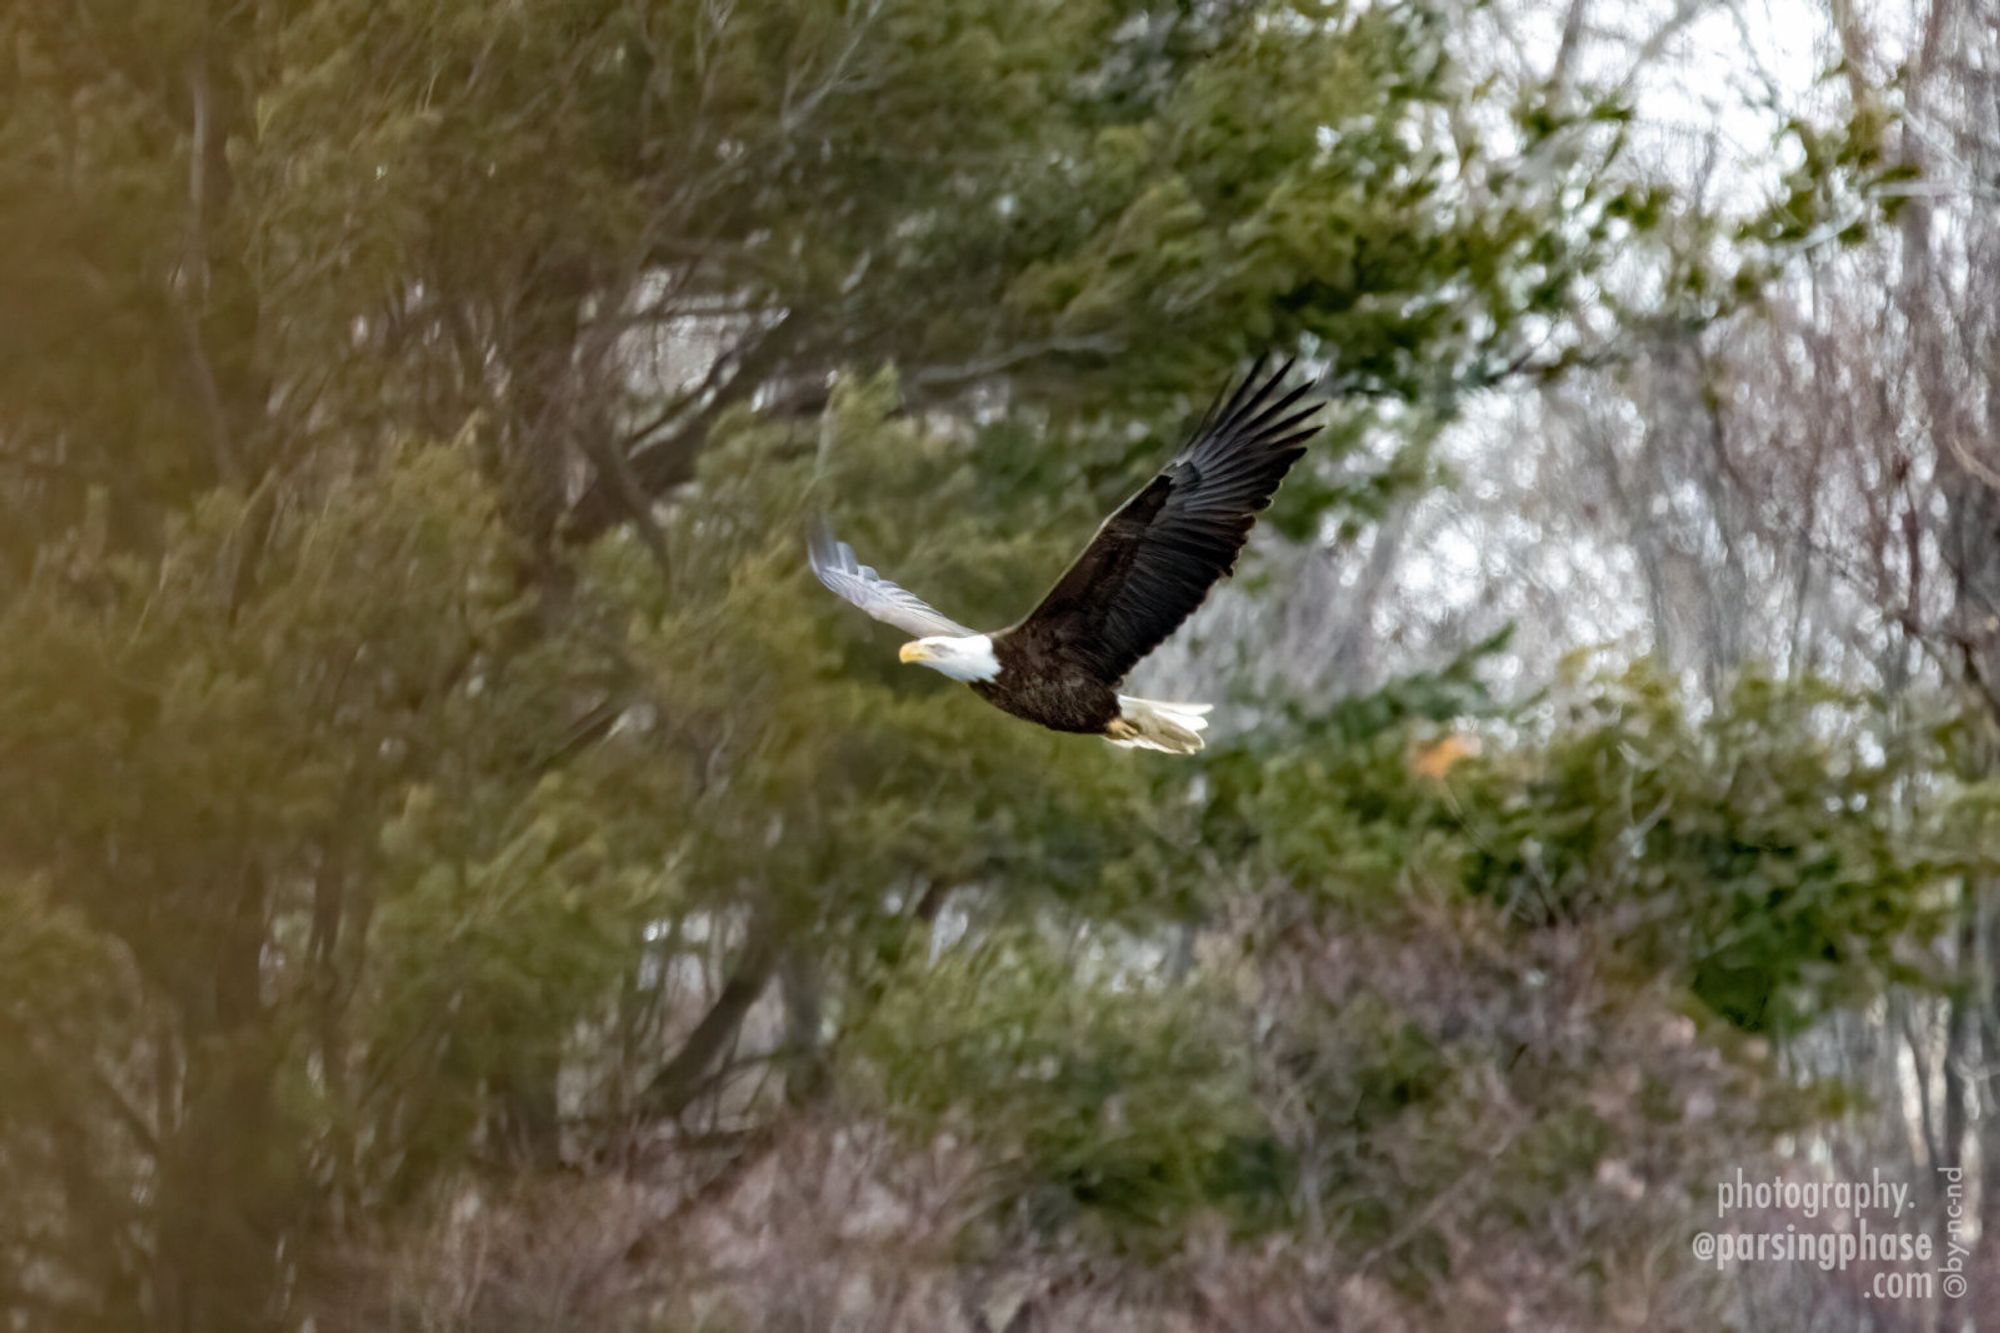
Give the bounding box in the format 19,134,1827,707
808,360,1320,755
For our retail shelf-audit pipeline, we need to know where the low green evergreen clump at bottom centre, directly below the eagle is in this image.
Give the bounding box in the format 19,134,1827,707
848,935,1272,1251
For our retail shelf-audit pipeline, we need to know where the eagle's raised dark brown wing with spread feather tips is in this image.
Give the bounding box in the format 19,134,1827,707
1006,358,1320,683
